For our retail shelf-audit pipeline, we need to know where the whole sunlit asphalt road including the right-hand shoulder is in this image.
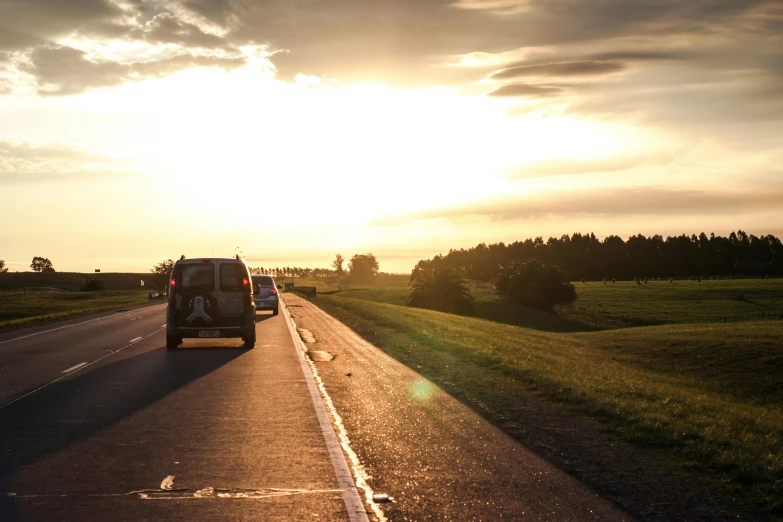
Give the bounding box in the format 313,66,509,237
0,295,630,520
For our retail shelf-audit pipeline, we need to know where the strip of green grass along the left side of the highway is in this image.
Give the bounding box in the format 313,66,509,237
0,290,155,331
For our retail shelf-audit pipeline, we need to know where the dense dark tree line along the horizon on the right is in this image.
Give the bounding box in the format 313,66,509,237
416,230,783,281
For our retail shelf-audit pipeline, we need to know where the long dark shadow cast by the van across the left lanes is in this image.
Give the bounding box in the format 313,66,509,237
0,347,247,520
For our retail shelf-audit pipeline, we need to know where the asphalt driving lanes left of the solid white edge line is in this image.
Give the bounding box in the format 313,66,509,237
0,306,360,520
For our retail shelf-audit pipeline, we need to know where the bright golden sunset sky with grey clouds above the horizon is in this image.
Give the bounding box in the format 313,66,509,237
0,0,783,273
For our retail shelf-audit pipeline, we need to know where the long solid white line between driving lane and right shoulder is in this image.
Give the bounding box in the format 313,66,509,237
280,299,369,522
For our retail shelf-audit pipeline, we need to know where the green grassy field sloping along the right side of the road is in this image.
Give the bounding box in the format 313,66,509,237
292,276,783,518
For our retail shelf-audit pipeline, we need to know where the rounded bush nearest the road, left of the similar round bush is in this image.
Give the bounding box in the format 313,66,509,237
407,267,473,315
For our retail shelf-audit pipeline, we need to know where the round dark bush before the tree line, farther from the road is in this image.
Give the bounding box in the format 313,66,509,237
495,261,576,311
